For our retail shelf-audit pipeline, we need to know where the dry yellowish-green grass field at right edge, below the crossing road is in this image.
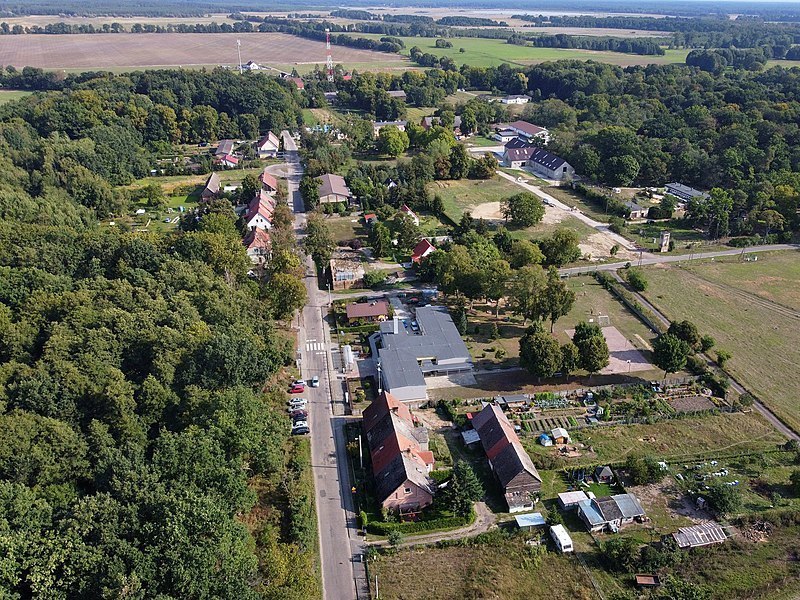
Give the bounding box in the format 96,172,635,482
646,251,800,430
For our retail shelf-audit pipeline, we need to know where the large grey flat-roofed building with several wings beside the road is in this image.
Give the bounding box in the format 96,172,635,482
370,306,472,403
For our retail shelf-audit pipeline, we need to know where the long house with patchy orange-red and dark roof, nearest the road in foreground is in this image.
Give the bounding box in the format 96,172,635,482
363,392,435,514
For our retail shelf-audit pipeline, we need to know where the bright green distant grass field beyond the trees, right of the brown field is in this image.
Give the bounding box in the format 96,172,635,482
354,33,688,67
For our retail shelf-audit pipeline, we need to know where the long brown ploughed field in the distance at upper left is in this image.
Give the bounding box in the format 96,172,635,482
0,33,402,70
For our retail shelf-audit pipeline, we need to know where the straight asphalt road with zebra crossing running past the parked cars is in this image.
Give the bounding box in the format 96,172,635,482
282,139,365,600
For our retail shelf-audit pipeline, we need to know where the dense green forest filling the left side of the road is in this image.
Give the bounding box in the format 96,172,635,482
0,65,319,600
